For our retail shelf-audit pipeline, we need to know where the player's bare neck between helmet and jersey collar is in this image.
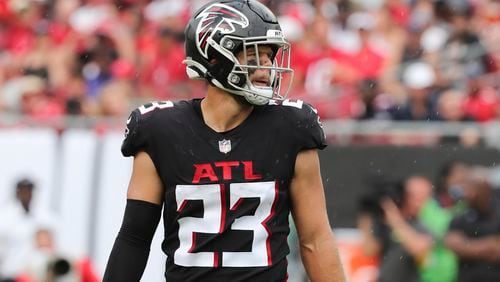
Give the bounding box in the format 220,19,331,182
201,87,253,132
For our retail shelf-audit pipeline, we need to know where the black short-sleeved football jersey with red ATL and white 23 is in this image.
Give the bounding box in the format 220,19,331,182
122,99,326,281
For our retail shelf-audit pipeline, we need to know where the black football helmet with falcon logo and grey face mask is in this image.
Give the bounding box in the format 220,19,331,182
184,0,293,105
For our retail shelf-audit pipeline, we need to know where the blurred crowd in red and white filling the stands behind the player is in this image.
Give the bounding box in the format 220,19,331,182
0,0,500,122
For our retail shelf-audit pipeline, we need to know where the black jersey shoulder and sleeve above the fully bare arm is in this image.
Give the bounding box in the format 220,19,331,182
270,99,326,150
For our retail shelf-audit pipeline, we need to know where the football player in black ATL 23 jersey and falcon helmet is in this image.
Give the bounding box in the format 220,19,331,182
104,0,344,281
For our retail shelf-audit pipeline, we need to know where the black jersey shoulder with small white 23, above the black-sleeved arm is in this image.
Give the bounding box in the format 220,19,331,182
121,101,174,157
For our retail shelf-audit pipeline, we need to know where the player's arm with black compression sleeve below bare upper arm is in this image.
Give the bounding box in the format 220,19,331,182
103,151,164,281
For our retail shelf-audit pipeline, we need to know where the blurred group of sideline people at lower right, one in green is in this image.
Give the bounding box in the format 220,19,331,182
358,161,500,282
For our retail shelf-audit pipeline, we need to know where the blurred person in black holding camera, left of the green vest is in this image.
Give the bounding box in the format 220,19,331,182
358,176,433,282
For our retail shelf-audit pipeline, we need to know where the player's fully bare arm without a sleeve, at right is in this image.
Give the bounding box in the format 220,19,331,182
290,149,345,281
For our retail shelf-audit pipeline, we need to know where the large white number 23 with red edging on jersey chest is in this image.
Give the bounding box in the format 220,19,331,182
174,181,276,267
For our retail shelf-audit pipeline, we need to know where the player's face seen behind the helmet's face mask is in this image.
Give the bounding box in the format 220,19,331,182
237,45,273,87
